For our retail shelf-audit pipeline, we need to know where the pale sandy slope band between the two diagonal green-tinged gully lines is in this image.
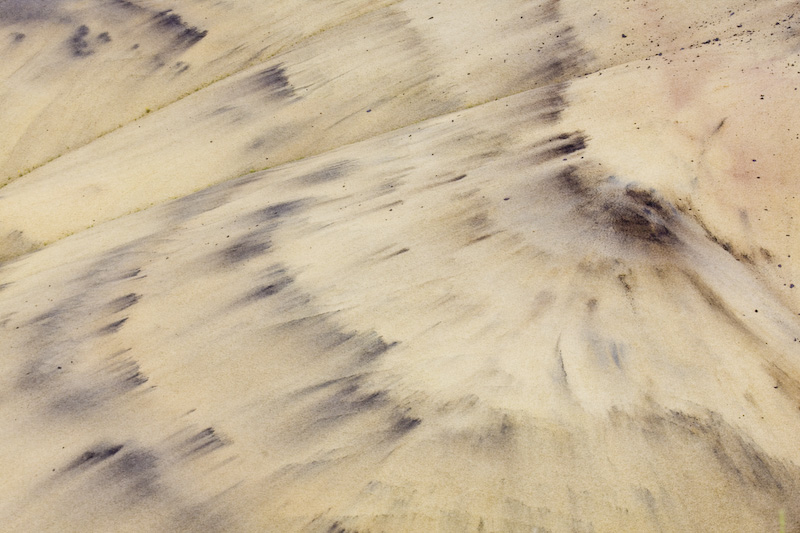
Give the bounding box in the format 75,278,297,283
0,0,592,258
